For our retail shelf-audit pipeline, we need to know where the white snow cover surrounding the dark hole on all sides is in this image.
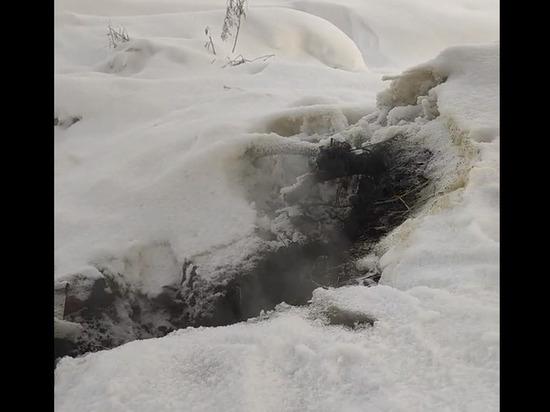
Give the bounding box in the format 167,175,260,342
54,0,500,412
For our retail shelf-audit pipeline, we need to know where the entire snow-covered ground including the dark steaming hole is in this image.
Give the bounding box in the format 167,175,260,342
54,0,500,412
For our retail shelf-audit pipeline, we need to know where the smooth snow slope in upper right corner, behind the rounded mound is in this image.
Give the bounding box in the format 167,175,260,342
291,0,500,71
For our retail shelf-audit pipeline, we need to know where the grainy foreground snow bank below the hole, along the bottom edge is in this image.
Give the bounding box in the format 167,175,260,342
55,286,498,412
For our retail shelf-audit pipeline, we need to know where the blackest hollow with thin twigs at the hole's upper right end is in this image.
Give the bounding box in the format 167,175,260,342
315,135,433,243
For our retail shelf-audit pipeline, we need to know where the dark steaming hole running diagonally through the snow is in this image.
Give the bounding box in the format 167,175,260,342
54,135,432,359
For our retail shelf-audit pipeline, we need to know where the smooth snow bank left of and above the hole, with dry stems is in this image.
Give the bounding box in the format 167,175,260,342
55,2,376,289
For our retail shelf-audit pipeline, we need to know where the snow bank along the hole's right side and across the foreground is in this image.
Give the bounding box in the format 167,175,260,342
55,39,499,412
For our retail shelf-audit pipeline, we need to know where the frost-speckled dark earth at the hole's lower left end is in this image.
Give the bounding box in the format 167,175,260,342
54,271,188,363
